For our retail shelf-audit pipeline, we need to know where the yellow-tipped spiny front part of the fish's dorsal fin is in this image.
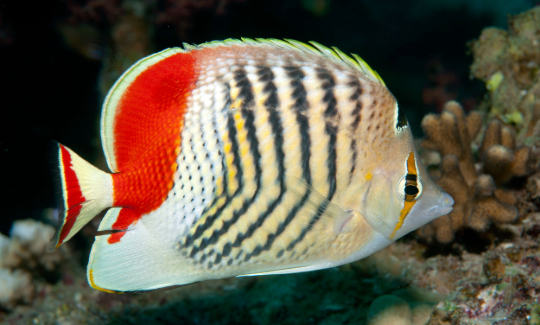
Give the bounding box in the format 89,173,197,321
184,38,386,85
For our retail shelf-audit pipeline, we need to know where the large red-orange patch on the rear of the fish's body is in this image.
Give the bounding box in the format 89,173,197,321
109,53,198,243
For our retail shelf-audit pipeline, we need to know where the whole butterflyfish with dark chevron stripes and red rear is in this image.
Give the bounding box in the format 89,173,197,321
51,40,453,292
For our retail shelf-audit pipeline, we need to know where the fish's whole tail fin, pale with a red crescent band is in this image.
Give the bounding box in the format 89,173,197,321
49,142,113,250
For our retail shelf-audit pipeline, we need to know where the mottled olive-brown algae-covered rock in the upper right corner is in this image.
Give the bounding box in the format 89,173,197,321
469,7,540,144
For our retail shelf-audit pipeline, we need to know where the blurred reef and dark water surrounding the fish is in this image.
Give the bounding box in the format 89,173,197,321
0,0,540,325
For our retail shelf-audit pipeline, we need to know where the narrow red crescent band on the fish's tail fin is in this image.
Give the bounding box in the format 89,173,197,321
57,145,86,247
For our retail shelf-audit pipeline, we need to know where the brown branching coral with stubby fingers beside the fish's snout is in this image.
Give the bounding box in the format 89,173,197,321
418,101,529,243
